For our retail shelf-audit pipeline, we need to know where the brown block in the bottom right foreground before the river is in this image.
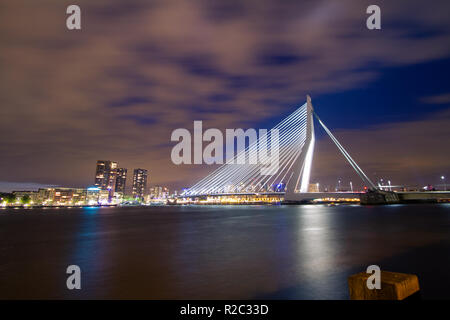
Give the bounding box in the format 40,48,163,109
348,271,419,300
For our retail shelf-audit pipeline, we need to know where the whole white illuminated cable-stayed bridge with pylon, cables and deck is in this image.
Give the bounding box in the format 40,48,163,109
179,96,448,203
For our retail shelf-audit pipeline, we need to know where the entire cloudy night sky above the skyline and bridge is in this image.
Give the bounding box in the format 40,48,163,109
0,0,450,191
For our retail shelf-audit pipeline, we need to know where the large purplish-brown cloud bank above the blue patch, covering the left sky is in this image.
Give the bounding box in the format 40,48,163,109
0,0,450,190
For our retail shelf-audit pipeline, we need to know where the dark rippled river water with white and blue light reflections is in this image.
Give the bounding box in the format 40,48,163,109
0,204,450,299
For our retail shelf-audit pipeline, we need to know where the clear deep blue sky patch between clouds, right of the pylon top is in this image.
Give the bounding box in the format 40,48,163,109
261,59,450,135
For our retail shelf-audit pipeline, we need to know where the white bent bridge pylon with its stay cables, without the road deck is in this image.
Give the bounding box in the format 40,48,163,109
181,95,376,200
